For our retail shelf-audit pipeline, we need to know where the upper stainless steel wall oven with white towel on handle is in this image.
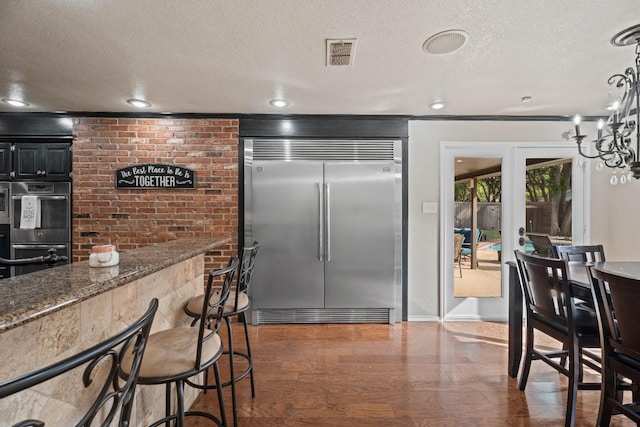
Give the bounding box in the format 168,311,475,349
10,182,71,243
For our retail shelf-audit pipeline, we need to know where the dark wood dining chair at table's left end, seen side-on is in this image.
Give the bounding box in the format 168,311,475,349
515,251,600,426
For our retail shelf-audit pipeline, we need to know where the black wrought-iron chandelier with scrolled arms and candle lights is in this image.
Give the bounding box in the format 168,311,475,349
573,25,640,185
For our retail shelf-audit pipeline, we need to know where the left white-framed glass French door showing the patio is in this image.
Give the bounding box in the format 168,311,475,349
440,143,512,320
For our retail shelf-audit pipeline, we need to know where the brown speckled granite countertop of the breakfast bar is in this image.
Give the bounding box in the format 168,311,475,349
0,239,231,333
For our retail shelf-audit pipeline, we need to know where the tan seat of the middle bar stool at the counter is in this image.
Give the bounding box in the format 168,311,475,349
122,327,222,382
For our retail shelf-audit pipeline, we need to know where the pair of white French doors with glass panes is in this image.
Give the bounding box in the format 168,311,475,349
440,142,588,321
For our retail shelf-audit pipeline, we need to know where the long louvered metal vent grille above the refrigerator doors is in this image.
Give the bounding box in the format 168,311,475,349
253,140,394,161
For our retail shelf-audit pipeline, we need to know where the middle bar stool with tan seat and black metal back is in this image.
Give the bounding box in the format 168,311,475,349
123,256,239,427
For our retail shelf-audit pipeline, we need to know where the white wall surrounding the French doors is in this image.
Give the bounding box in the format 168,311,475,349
407,120,612,320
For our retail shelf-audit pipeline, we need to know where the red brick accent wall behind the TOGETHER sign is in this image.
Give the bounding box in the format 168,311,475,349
72,118,239,271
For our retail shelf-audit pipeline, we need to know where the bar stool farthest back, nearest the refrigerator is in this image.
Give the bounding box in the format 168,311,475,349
184,242,260,425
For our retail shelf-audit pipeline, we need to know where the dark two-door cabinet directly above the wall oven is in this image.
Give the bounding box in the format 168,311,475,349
13,143,71,181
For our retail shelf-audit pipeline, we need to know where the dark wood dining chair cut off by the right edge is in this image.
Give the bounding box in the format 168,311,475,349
588,266,640,426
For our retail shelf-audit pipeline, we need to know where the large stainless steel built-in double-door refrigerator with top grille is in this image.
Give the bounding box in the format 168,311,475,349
245,140,402,324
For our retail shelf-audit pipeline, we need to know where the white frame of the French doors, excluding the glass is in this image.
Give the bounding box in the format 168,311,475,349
439,141,590,321
